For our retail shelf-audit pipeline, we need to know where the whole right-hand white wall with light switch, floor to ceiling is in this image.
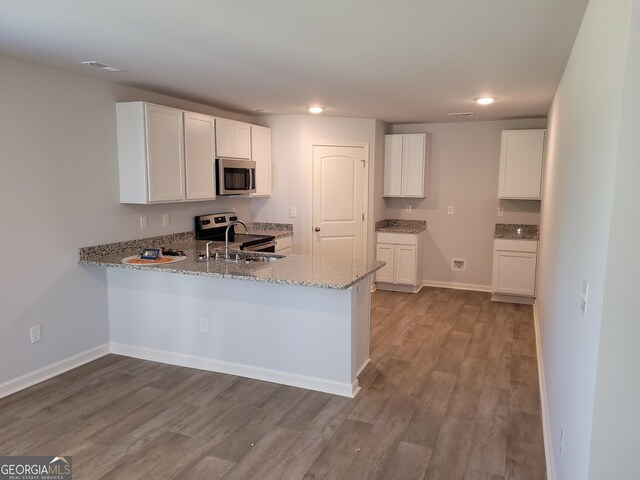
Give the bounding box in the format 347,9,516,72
537,0,640,480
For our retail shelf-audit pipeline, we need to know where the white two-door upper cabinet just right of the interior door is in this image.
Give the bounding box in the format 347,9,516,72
383,133,427,198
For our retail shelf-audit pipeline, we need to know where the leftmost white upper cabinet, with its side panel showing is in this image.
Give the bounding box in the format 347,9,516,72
116,102,185,203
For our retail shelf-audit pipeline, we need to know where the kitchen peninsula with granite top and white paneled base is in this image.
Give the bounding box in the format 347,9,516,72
79,232,383,397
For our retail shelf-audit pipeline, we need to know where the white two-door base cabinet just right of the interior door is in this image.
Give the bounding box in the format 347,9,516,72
376,232,422,292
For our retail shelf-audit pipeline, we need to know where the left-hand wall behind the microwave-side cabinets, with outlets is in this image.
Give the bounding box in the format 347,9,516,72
0,57,258,384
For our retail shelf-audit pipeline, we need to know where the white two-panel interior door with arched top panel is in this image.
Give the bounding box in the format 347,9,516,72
311,145,366,259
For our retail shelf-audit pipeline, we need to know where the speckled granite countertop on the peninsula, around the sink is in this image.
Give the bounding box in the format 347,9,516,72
78,232,384,290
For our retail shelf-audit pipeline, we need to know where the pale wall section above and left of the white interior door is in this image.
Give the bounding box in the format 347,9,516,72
253,115,382,258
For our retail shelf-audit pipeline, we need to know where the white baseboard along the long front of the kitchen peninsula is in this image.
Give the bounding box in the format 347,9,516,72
111,342,360,398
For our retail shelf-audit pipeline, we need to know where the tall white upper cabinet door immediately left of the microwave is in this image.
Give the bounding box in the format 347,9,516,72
184,112,216,200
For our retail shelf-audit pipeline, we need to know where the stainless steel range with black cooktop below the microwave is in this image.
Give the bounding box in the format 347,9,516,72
195,212,276,253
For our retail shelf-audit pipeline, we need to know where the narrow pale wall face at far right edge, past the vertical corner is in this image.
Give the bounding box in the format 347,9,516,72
589,0,640,480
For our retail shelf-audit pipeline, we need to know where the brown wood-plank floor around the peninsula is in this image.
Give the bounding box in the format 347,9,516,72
0,288,545,480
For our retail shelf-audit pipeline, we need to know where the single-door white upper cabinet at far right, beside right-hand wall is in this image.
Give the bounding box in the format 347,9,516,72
498,129,546,200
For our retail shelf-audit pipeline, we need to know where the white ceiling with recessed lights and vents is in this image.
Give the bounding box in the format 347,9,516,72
0,0,588,123
